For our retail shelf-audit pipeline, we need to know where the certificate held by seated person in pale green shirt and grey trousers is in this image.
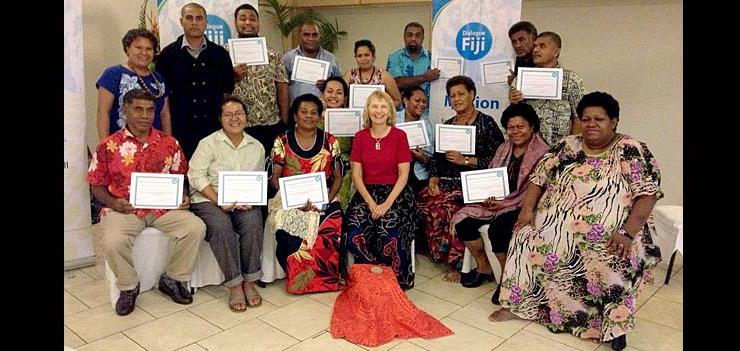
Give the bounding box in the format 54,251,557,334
218,171,267,206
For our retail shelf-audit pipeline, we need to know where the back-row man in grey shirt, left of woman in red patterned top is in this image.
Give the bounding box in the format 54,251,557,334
283,20,342,104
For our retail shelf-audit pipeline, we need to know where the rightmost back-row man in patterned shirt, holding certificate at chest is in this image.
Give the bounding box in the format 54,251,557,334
509,32,584,146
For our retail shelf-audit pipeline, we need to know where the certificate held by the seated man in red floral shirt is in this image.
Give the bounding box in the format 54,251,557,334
128,172,185,209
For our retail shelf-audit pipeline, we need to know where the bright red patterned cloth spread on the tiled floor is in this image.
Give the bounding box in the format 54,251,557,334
331,264,452,346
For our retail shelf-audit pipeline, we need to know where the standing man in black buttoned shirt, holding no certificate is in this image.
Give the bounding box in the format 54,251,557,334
156,3,234,159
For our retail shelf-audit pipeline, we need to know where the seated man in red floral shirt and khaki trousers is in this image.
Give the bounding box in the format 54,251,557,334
87,89,206,316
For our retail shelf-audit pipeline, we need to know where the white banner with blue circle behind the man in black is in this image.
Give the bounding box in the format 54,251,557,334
157,0,259,48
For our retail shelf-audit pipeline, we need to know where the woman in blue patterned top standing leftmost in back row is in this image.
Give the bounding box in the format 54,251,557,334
95,28,172,140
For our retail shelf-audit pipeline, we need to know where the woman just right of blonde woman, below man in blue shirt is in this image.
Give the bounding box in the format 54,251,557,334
396,85,434,194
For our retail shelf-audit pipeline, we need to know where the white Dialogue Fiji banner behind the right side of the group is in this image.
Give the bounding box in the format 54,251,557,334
429,0,522,126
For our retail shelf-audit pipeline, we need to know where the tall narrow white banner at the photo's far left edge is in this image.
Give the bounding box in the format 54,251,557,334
64,0,95,270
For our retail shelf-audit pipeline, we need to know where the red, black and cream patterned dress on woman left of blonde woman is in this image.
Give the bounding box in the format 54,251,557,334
268,129,344,294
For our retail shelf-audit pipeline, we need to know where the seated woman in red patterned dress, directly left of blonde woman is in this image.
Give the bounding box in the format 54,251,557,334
262,94,343,294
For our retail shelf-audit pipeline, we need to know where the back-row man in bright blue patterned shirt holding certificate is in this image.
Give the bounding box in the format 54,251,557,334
385,22,439,111
